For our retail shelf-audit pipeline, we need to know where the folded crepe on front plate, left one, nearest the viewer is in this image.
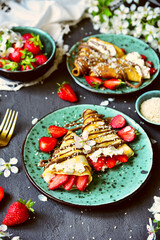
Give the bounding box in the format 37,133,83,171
42,131,92,189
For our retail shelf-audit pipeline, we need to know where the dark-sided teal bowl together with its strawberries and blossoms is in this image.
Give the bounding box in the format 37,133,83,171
0,26,56,82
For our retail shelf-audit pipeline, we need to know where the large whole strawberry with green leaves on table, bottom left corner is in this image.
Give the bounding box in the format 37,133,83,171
3,199,35,226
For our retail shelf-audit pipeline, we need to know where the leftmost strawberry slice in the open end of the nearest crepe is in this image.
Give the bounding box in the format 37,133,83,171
48,174,69,190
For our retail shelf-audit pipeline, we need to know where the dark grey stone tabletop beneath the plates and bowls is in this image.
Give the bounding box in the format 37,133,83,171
0,10,160,240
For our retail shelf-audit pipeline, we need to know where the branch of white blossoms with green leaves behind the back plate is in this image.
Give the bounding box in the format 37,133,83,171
88,0,160,52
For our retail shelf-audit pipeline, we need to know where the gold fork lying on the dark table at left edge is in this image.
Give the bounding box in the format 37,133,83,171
0,108,18,147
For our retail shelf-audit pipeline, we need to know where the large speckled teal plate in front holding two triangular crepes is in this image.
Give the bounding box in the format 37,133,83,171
22,105,152,206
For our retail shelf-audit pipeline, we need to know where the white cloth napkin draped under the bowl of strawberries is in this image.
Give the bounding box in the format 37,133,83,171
0,0,87,91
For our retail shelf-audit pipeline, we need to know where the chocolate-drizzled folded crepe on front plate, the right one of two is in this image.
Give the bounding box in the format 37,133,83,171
82,109,134,170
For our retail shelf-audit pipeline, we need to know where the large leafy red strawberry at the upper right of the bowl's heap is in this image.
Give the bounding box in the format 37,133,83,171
24,35,43,56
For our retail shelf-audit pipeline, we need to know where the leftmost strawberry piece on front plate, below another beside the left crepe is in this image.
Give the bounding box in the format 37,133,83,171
39,137,57,152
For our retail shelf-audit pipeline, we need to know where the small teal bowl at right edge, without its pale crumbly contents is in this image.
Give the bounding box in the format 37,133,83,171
135,90,160,126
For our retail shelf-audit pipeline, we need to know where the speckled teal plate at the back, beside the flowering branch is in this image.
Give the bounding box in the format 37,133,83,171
67,34,159,94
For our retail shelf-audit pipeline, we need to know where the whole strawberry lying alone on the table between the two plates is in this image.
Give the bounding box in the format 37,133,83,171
58,82,77,102
